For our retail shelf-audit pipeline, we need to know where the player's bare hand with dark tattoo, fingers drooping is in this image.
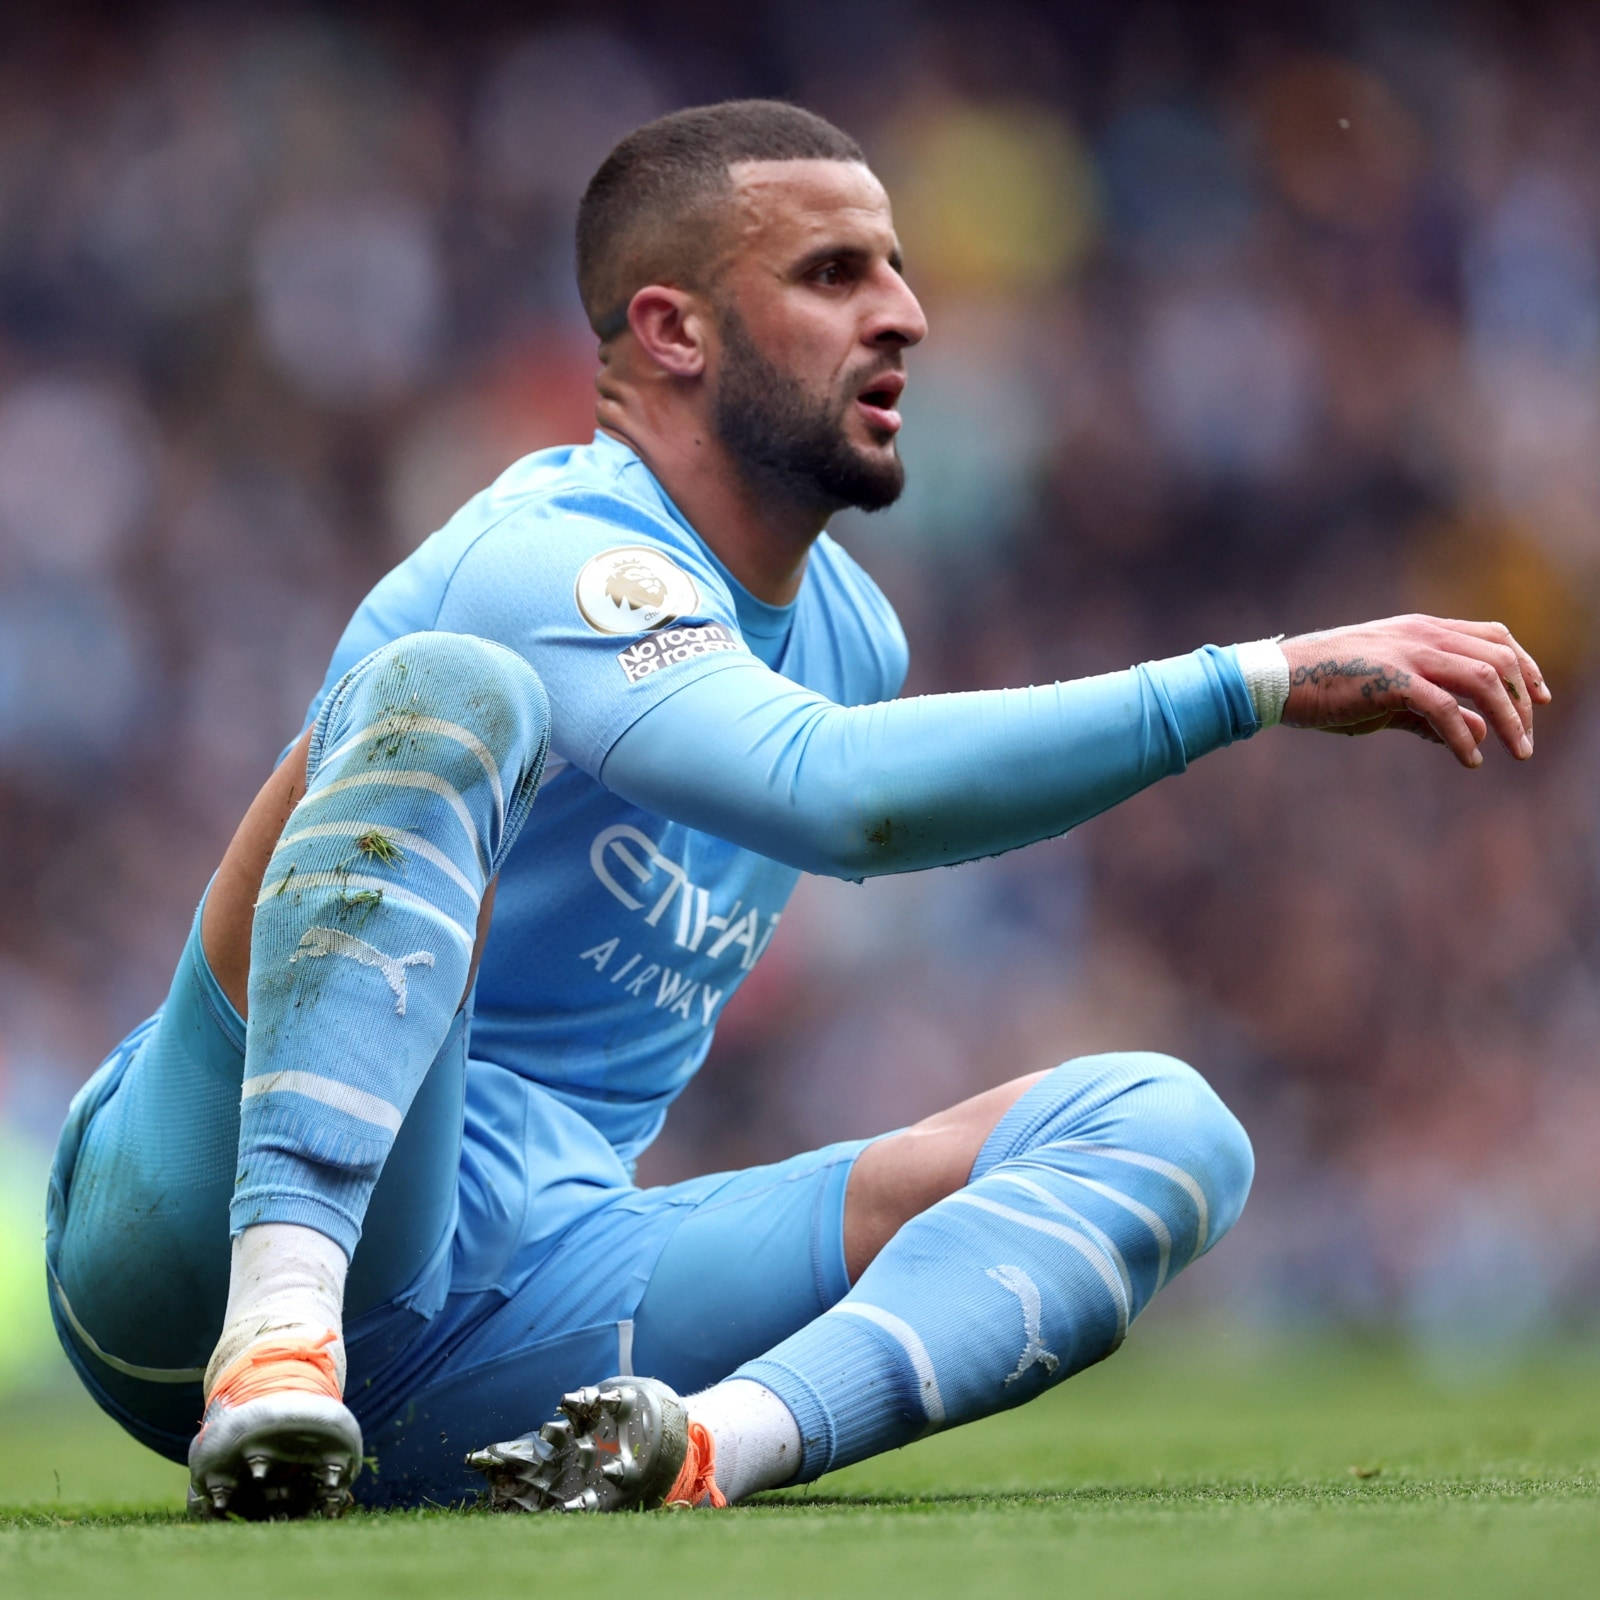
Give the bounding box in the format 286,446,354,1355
1283,616,1550,766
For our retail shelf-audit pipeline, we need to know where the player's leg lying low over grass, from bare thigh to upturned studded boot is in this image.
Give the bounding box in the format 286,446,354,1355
473,1054,1253,1506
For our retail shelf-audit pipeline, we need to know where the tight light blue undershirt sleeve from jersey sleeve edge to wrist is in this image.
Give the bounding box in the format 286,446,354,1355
603,645,1259,878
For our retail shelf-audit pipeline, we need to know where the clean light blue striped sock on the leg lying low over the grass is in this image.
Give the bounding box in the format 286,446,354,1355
733,1054,1254,1482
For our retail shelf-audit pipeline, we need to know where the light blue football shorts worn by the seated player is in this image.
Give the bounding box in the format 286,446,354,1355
46,917,870,1504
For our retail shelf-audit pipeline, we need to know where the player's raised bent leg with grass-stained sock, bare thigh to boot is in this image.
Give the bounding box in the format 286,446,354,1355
51,634,549,1510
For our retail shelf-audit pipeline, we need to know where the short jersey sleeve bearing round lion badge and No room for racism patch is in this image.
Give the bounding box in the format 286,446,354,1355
434,493,760,776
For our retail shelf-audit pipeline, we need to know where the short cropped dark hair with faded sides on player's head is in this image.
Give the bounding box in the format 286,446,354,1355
578,101,866,342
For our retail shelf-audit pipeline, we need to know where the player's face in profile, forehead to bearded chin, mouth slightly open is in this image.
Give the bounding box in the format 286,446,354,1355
712,162,928,510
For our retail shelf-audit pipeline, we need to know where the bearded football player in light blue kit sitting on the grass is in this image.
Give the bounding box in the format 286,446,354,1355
48,101,1549,1517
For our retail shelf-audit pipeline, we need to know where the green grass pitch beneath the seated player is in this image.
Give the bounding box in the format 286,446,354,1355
0,1328,1600,1600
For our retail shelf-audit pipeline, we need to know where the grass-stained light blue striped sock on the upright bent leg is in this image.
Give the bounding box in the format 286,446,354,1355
230,634,550,1256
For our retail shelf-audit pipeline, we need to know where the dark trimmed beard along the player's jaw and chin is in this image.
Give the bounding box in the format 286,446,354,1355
712,310,906,512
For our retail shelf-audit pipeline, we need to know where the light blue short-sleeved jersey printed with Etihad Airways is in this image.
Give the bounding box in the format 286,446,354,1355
300,434,907,1165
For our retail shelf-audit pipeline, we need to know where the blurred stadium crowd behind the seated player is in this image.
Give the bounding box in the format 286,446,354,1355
0,0,1600,1389
